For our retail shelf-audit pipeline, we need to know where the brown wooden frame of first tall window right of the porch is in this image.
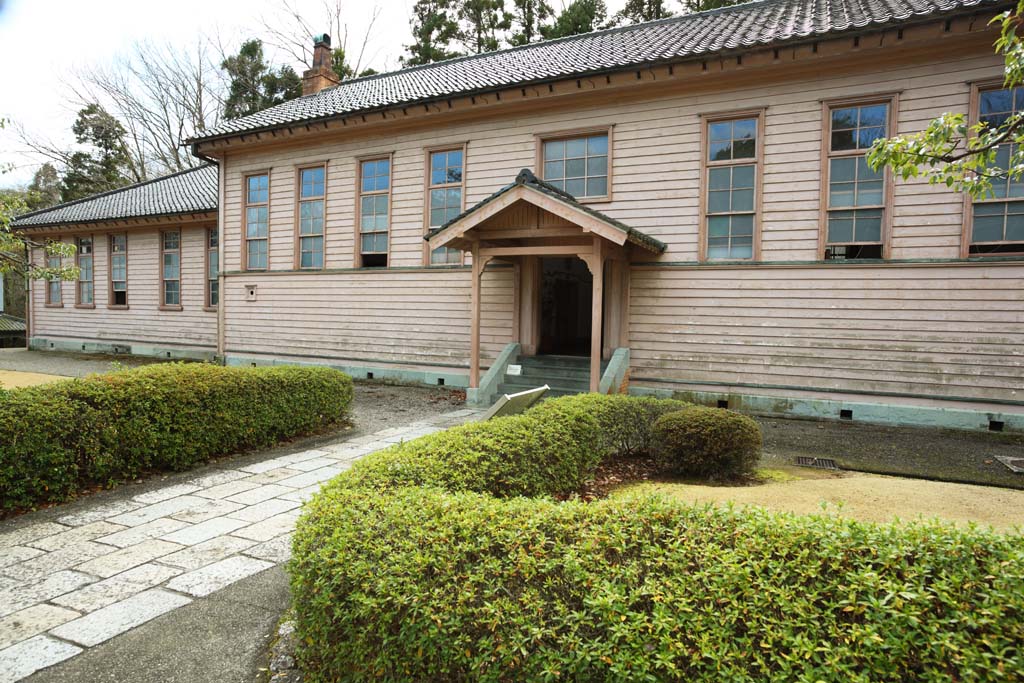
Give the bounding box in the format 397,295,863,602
698,106,767,263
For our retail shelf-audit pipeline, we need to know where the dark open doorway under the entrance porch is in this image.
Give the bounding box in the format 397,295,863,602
538,258,594,355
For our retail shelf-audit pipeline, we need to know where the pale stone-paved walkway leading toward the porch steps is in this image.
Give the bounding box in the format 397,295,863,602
0,409,478,683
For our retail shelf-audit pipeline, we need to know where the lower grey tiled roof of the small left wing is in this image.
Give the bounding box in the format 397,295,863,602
13,164,217,228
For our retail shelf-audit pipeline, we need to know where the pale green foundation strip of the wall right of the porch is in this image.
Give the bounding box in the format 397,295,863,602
630,386,1024,433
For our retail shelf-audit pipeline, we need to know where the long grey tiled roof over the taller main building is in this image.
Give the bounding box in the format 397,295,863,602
191,0,1009,142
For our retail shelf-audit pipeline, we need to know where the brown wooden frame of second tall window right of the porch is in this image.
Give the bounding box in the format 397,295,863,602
818,92,899,263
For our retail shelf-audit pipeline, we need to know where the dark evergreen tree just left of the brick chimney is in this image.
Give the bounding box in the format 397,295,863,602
220,39,302,119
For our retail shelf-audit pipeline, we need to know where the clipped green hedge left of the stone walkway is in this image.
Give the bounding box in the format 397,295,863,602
0,364,352,510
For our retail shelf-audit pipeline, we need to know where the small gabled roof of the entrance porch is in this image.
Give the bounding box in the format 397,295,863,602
424,168,668,254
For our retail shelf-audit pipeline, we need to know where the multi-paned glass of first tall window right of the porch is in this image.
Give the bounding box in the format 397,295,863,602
705,117,759,259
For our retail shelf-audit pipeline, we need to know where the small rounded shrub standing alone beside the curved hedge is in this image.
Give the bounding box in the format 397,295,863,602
651,405,762,479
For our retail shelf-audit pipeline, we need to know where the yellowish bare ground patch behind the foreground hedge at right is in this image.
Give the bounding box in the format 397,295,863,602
612,467,1024,532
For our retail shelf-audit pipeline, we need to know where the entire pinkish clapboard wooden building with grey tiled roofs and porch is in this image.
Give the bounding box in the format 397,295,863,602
17,0,1024,430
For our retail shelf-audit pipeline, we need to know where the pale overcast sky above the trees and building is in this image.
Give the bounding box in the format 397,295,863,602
0,0,625,187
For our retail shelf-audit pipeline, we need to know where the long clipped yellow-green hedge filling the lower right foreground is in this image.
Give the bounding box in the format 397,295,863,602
292,486,1024,682
